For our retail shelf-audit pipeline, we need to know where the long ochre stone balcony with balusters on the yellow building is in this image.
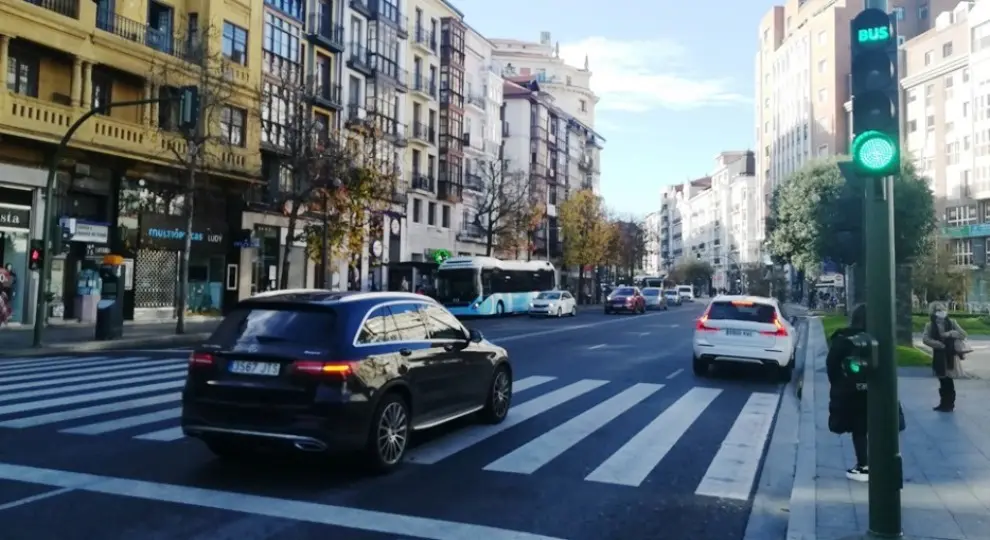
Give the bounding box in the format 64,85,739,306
0,89,261,177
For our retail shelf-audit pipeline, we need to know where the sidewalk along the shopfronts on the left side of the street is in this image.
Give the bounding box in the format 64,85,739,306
0,319,219,362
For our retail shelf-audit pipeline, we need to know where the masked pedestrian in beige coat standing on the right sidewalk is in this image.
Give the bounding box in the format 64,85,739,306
921,302,966,412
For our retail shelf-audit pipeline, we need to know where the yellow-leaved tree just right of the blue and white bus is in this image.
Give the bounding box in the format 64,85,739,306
559,190,616,298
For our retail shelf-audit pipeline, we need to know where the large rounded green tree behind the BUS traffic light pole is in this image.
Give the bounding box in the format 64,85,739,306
768,159,935,272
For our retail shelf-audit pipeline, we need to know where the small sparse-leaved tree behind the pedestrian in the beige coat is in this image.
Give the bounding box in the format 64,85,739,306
911,235,971,303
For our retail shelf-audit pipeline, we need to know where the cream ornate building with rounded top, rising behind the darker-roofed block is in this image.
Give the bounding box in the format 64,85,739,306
491,32,605,193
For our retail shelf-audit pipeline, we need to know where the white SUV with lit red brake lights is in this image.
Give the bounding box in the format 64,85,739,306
692,296,797,381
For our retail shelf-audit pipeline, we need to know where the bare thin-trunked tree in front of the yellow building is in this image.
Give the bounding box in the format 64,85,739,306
150,25,256,334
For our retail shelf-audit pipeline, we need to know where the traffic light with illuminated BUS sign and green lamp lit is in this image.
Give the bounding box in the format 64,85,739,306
850,8,901,177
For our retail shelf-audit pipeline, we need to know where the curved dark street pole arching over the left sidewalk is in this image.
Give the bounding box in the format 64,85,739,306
32,98,170,347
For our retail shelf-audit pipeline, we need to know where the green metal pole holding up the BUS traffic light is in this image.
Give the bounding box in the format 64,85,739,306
864,176,903,538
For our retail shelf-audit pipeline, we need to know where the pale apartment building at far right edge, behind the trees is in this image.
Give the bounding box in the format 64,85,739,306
901,2,990,302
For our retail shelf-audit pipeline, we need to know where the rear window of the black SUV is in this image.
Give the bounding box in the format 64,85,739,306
210,306,337,348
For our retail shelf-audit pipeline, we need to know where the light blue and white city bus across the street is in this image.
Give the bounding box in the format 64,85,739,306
436,257,557,317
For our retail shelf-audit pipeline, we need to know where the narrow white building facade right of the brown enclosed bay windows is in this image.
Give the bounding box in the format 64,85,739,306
457,26,503,255
